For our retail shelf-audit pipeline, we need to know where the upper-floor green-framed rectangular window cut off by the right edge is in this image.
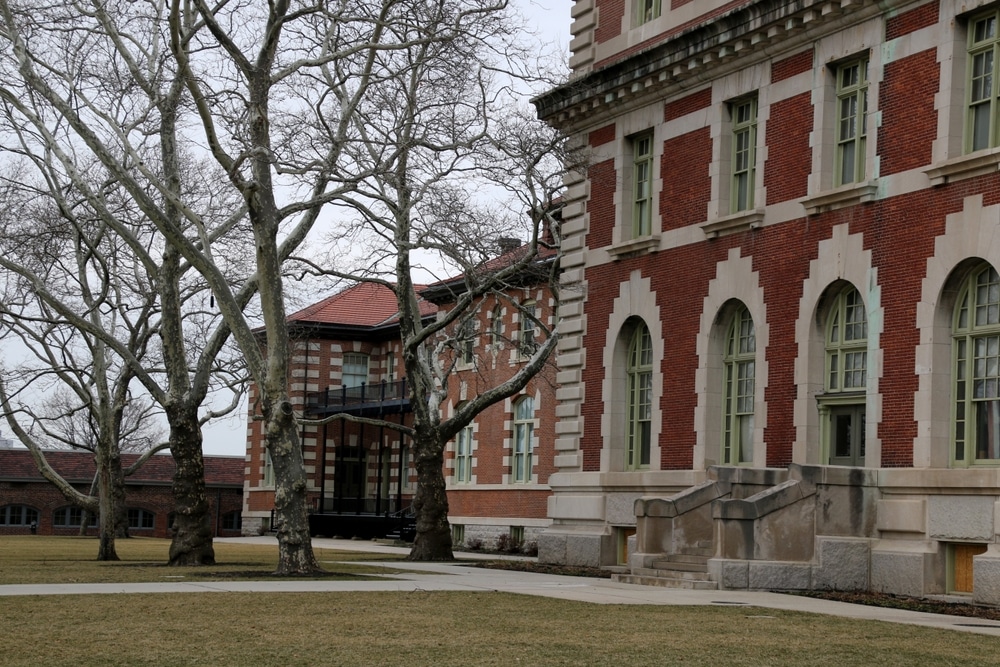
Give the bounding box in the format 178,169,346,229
965,9,1000,152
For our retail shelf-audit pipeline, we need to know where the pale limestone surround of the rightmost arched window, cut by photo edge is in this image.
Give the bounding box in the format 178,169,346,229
913,194,1000,468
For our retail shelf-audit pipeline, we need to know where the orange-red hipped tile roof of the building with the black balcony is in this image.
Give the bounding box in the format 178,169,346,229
288,283,437,327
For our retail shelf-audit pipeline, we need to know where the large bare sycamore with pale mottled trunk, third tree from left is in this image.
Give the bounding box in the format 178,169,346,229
0,0,544,574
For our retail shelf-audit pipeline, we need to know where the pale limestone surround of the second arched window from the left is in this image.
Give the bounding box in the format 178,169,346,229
693,248,770,470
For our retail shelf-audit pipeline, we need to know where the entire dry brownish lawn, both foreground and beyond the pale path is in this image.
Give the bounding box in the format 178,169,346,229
0,537,1000,667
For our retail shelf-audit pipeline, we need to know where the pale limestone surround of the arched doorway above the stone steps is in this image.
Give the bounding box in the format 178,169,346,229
792,224,884,468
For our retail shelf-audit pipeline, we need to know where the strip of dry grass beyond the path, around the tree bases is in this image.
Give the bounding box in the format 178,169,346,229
0,535,401,585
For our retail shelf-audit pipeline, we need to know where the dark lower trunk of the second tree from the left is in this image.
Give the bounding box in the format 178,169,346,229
168,409,215,565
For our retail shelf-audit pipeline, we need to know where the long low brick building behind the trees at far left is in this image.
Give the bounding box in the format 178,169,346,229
0,448,244,537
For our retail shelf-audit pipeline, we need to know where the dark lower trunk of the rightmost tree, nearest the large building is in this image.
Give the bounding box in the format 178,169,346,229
406,435,455,561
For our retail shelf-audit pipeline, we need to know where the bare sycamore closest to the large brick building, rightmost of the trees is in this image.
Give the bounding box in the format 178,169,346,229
303,2,573,560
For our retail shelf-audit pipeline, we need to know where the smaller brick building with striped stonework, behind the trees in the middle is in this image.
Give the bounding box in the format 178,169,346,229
243,256,555,546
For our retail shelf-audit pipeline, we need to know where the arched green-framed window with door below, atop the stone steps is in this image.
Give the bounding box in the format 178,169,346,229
820,286,868,466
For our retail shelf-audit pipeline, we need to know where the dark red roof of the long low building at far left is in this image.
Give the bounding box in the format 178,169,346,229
0,449,246,486
